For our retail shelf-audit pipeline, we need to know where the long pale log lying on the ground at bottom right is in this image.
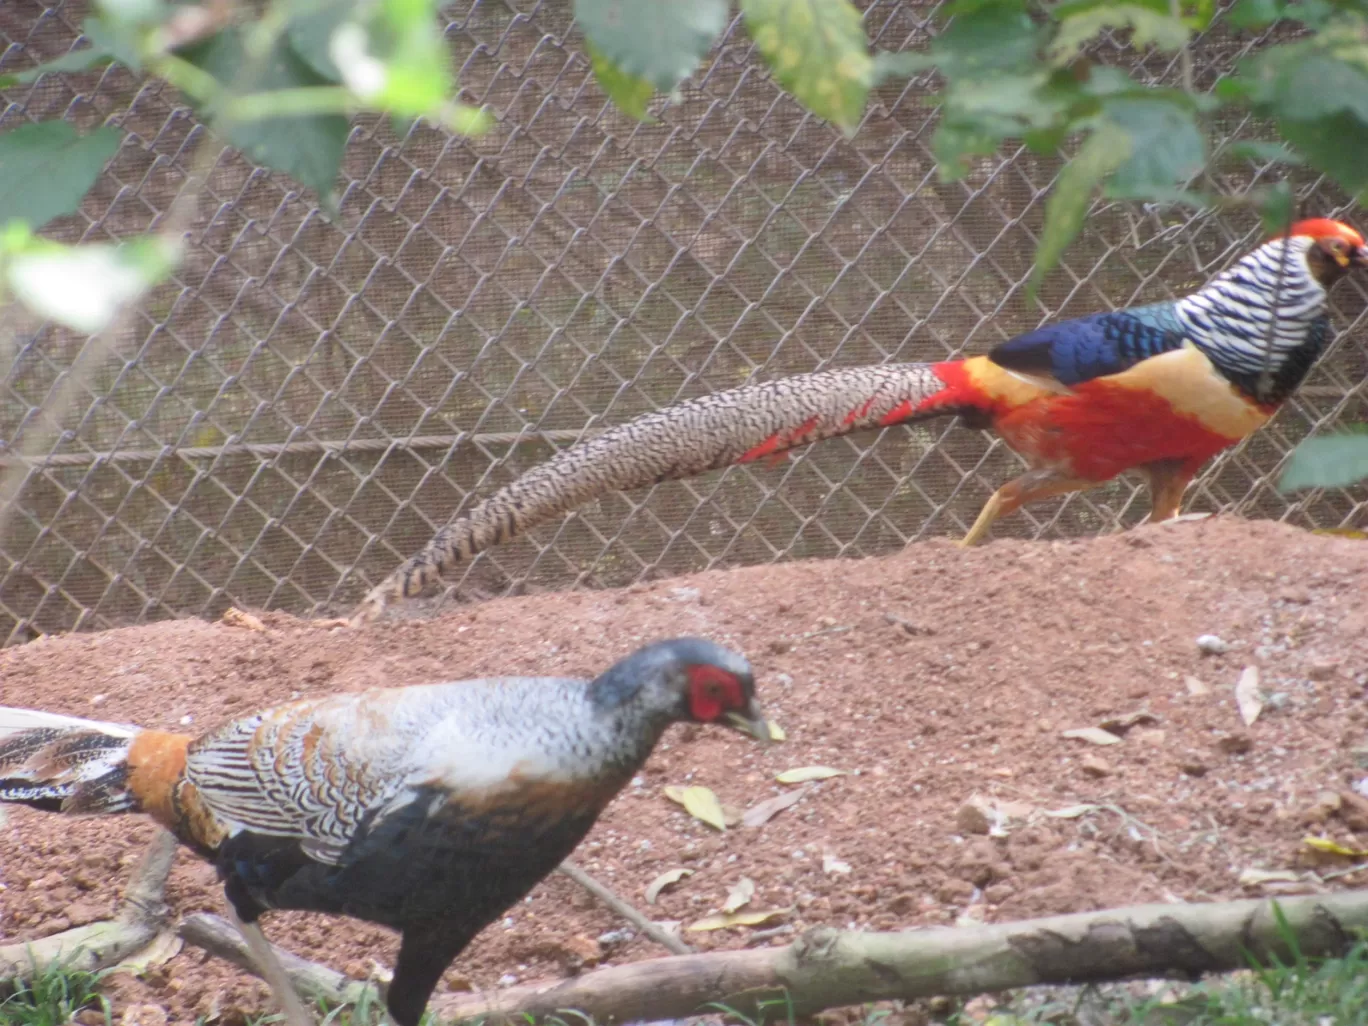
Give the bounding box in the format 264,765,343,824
432,892,1368,1023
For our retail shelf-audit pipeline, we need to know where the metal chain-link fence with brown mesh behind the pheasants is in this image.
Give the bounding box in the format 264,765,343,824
0,0,1368,642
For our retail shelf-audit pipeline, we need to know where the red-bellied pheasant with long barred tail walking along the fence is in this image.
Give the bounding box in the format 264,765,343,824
352,219,1368,624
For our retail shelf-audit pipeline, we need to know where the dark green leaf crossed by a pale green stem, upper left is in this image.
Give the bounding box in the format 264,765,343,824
182,27,350,205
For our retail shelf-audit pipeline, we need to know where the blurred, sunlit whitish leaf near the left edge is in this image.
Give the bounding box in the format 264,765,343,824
5,238,178,335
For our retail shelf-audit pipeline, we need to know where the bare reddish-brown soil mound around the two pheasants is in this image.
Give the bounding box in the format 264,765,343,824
0,520,1368,1022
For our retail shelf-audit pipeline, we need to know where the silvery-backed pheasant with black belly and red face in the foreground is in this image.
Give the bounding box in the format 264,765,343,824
0,637,769,1026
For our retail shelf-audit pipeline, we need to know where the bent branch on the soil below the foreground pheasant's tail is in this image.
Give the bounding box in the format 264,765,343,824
0,830,176,984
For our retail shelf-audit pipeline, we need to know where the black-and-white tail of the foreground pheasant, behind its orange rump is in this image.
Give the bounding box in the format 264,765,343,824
0,706,138,814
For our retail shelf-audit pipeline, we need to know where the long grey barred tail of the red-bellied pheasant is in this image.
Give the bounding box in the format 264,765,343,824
352,364,959,625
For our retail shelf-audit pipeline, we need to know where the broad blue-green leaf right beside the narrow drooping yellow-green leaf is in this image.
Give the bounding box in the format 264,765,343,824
1103,98,1207,198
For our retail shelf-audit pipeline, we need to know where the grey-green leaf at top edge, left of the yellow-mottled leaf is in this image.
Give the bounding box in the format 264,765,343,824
575,0,728,93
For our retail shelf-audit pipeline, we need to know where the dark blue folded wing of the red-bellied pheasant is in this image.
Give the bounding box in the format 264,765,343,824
988,302,1183,386
